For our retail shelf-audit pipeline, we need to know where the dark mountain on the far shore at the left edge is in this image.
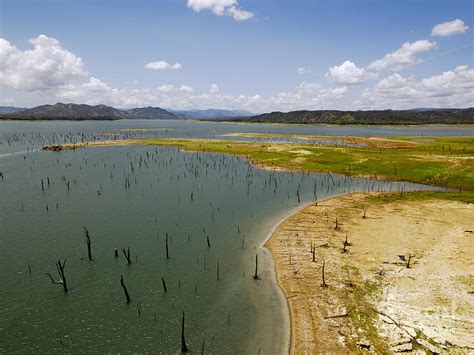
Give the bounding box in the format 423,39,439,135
0,103,134,121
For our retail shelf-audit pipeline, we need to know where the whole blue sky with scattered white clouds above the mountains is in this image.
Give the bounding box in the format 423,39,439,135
0,0,474,113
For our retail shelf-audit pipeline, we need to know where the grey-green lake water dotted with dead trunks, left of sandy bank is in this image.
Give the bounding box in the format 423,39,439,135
0,121,444,354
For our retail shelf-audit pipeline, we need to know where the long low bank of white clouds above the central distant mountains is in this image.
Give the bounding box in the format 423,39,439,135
55,77,347,112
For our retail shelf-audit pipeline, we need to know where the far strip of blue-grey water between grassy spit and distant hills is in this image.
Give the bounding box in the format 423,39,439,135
0,120,474,154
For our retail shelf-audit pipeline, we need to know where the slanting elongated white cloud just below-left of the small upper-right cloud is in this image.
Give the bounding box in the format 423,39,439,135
367,40,436,71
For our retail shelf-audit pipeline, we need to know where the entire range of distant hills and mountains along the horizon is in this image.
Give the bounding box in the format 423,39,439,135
0,103,474,125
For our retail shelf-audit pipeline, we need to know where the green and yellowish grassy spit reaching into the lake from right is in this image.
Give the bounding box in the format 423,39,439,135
43,134,474,191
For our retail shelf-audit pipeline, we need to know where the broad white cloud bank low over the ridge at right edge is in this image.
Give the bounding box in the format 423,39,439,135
356,65,474,109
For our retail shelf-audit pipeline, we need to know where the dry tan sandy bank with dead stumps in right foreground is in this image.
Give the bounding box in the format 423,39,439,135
266,193,474,354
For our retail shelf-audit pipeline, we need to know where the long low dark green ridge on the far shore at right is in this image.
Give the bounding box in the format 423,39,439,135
227,107,474,125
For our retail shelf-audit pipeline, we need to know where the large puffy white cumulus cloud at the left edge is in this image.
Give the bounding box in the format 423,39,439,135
0,35,87,91
